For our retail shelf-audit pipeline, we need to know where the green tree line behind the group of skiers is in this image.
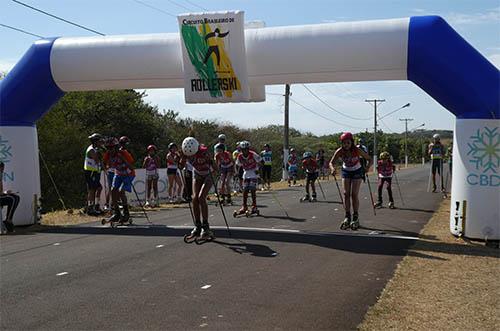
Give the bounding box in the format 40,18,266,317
37,90,452,212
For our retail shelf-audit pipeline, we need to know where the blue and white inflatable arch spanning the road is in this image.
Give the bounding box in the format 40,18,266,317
0,16,500,240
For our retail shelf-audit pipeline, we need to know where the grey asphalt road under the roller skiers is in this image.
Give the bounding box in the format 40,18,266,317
0,168,442,330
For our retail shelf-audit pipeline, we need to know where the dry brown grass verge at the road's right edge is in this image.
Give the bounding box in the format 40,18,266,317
359,200,500,330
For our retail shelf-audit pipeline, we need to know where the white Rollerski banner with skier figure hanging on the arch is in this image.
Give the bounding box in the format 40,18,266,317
178,11,250,103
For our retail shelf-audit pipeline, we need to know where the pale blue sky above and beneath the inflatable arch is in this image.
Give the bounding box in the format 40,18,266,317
0,0,500,135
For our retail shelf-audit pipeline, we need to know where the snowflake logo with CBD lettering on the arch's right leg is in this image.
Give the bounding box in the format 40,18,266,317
467,127,500,187
